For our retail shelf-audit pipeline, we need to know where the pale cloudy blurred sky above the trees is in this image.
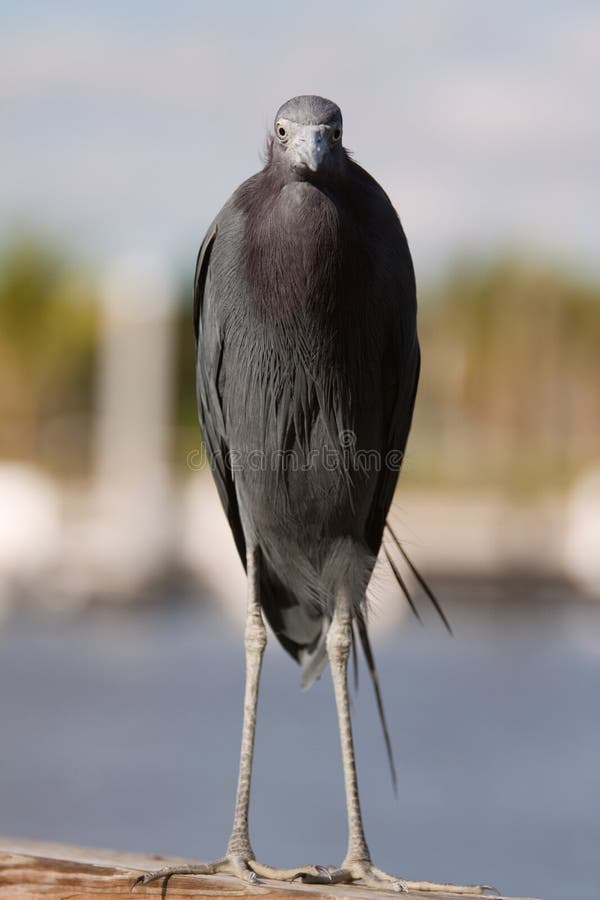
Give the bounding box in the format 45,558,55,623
0,0,600,278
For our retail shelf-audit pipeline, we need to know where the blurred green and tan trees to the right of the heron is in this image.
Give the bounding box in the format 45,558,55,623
411,260,600,492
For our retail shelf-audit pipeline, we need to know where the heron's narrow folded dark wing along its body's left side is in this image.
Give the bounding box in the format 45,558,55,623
194,217,246,567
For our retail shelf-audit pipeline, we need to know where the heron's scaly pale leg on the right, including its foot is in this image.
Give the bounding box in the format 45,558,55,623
318,594,493,895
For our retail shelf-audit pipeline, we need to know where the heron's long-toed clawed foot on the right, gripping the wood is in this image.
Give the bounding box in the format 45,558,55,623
290,860,498,896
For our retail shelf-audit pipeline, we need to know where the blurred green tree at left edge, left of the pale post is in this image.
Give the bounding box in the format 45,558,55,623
0,236,98,474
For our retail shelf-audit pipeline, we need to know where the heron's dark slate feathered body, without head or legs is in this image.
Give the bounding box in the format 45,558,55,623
196,107,419,678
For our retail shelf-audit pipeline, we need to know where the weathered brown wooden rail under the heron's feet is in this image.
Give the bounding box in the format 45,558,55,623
0,838,540,900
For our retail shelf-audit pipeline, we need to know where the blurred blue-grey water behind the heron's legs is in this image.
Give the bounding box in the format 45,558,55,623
0,592,600,900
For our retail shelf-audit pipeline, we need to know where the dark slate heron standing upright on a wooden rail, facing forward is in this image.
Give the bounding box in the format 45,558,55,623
135,96,484,893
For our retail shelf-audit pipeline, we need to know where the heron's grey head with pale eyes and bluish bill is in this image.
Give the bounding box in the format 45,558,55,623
273,95,344,178
